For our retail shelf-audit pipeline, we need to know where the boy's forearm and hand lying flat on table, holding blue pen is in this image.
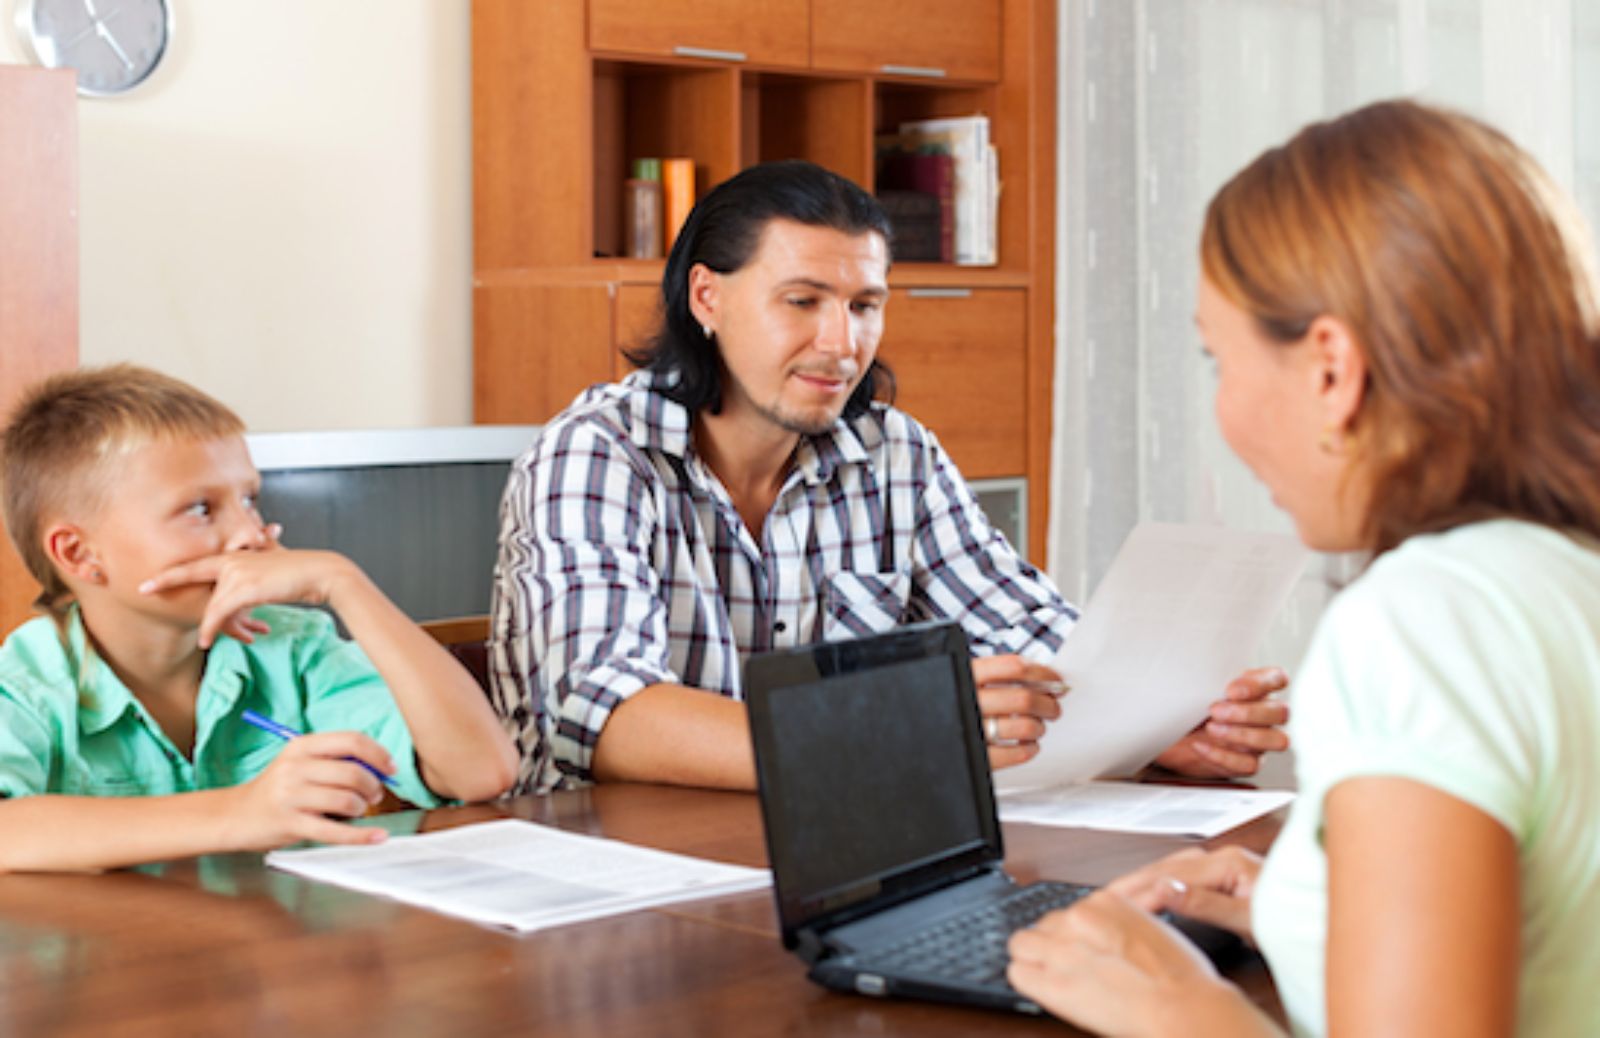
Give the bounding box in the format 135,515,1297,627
0,733,394,872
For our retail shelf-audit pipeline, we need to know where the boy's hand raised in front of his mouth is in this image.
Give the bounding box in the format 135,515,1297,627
139,549,360,648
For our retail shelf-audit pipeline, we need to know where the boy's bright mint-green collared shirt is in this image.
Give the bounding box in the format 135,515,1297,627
0,606,440,806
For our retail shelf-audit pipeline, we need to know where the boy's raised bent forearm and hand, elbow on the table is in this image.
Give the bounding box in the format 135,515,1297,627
141,549,517,800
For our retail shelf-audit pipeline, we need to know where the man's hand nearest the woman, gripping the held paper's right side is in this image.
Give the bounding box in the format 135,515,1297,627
1155,667,1290,779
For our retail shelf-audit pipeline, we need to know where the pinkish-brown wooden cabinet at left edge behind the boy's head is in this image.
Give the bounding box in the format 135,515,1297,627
0,66,78,638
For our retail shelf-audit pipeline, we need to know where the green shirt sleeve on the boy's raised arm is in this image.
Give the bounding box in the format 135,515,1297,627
294,611,446,808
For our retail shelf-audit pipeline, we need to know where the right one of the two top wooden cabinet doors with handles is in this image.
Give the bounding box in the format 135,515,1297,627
811,0,1000,82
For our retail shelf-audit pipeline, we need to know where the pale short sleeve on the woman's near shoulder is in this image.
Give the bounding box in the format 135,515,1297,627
1293,560,1539,841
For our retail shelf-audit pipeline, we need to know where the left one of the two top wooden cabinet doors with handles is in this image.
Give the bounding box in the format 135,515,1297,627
589,0,811,69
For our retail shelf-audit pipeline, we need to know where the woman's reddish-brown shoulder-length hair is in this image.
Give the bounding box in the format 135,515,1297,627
1200,101,1600,553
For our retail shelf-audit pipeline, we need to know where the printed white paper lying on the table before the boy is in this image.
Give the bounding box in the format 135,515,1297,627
267,819,771,931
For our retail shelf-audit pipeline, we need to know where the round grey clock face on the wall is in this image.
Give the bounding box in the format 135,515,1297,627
16,0,171,98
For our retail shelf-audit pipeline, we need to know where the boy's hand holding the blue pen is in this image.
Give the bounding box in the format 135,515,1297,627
229,731,395,851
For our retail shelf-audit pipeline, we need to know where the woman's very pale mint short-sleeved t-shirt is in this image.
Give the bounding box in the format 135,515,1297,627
1253,520,1600,1035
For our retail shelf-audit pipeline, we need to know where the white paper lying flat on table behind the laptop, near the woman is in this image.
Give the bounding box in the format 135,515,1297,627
1000,782,1294,836
